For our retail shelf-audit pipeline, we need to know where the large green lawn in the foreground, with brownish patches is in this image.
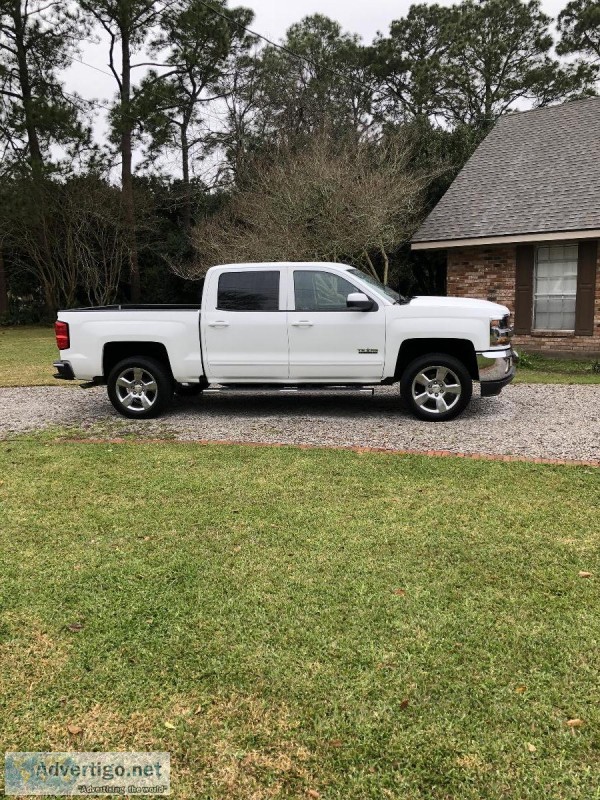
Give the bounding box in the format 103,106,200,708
0,435,600,800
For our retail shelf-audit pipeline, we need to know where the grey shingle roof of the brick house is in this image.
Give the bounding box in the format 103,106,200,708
413,97,600,242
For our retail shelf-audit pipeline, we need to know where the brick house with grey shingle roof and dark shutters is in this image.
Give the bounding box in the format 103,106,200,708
412,97,600,356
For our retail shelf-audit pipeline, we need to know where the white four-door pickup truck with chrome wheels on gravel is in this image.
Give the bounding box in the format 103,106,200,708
54,262,516,421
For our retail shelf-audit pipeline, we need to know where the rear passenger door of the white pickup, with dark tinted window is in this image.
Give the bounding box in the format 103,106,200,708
201,266,289,383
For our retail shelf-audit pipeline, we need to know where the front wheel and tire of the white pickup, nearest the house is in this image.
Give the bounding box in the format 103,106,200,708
400,353,473,422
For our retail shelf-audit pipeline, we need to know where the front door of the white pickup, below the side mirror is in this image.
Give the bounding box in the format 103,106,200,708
288,268,385,383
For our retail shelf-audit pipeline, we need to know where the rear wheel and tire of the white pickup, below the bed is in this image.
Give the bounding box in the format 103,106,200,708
107,356,173,419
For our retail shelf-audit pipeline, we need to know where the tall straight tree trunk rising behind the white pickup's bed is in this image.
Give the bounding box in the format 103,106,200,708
121,28,141,303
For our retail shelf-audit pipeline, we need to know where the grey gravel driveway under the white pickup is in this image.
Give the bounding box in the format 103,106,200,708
0,384,600,461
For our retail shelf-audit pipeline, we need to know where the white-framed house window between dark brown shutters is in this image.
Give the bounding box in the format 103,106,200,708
533,244,577,331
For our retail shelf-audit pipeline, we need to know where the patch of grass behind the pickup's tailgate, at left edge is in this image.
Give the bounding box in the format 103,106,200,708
0,326,61,386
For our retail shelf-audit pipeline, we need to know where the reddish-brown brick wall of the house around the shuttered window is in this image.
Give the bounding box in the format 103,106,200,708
448,245,600,356
